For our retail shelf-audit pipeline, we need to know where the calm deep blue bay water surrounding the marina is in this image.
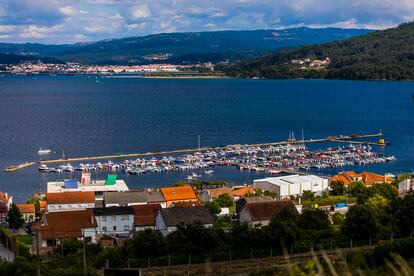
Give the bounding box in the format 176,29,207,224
0,76,414,202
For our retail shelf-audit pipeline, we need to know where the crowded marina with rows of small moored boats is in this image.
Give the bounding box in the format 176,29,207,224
32,134,396,178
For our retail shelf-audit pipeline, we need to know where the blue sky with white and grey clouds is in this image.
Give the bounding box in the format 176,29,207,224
0,0,414,44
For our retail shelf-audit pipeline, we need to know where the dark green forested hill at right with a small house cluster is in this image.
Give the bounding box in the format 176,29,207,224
225,23,414,80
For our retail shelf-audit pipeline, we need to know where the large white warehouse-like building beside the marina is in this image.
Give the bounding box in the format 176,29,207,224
253,174,329,198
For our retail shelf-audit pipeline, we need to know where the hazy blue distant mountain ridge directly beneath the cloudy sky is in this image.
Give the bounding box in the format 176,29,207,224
0,28,371,64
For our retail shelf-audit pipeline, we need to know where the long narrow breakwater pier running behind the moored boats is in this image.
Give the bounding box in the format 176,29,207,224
4,132,383,172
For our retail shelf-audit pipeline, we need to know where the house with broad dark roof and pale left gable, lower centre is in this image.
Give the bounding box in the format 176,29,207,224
155,206,213,236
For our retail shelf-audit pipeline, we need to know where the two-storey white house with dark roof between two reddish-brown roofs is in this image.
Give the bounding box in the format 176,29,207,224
93,206,134,237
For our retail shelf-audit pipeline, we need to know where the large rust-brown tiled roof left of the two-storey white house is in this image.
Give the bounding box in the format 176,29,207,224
39,209,98,240
